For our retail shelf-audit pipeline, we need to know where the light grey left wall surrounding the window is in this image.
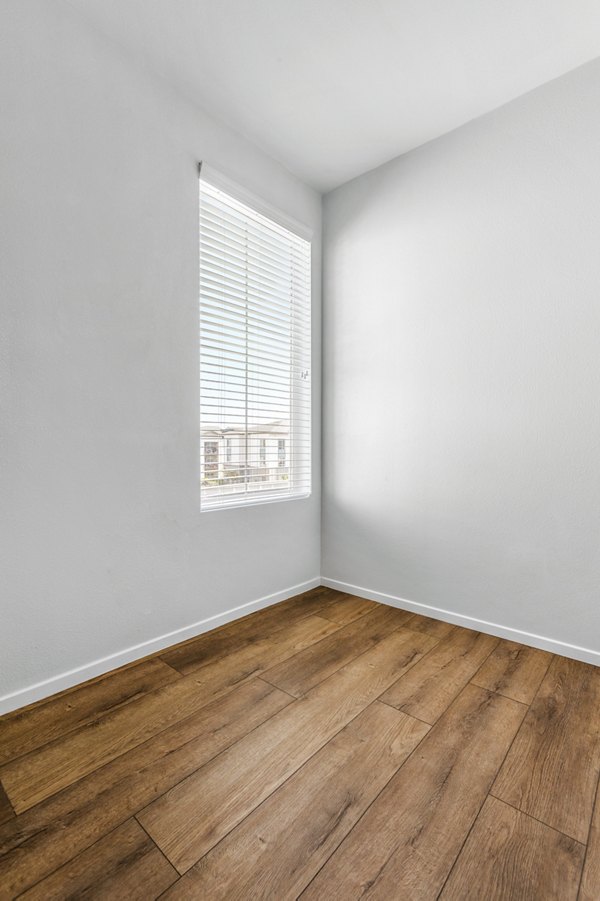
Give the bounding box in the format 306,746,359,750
0,0,320,708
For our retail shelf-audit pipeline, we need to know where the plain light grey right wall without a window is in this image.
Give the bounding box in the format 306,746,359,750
322,61,600,651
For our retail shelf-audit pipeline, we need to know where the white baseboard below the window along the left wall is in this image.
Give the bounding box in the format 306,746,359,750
0,576,321,715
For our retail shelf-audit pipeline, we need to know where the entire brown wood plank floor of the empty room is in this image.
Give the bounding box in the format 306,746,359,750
0,588,600,901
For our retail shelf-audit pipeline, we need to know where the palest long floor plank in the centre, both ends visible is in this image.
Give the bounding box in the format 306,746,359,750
138,630,433,873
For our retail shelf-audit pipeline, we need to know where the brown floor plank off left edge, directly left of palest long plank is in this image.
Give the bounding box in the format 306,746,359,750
0,680,292,898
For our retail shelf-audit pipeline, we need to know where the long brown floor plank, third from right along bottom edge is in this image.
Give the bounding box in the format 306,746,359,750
302,685,524,901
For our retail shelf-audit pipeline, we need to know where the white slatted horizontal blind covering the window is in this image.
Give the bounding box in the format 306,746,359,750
200,170,311,510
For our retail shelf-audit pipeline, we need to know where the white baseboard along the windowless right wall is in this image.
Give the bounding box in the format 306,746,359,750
321,576,600,666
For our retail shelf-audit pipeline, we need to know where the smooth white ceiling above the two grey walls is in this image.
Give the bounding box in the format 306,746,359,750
70,0,600,191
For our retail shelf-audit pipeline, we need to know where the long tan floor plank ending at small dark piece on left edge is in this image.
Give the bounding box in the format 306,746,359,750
0,616,340,813
